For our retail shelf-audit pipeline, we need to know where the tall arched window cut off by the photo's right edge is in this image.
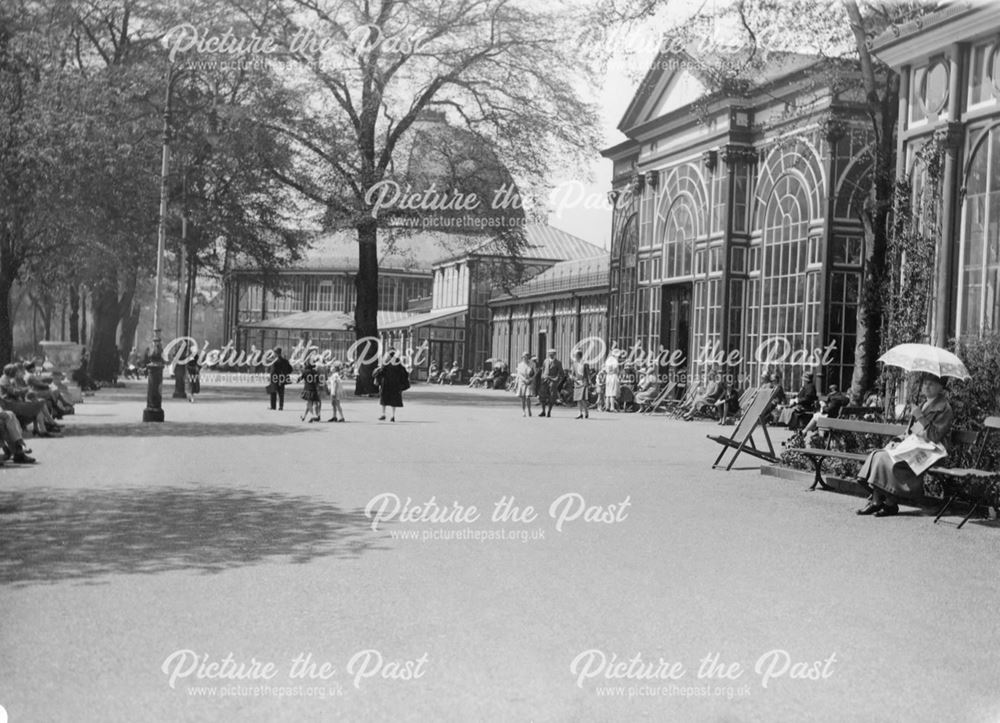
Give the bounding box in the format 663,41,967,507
958,126,1000,335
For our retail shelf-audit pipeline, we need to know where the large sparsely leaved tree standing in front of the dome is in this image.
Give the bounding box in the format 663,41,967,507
224,0,597,394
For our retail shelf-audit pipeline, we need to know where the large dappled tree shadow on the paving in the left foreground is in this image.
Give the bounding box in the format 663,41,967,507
0,487,383,586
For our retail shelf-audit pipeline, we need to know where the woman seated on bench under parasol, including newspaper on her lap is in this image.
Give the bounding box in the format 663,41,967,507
858,374,954,517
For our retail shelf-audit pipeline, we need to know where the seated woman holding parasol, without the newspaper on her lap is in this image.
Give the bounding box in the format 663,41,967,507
858,374,954,517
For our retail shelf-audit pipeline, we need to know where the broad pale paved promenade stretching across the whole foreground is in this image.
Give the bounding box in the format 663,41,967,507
0,382,1000,723
